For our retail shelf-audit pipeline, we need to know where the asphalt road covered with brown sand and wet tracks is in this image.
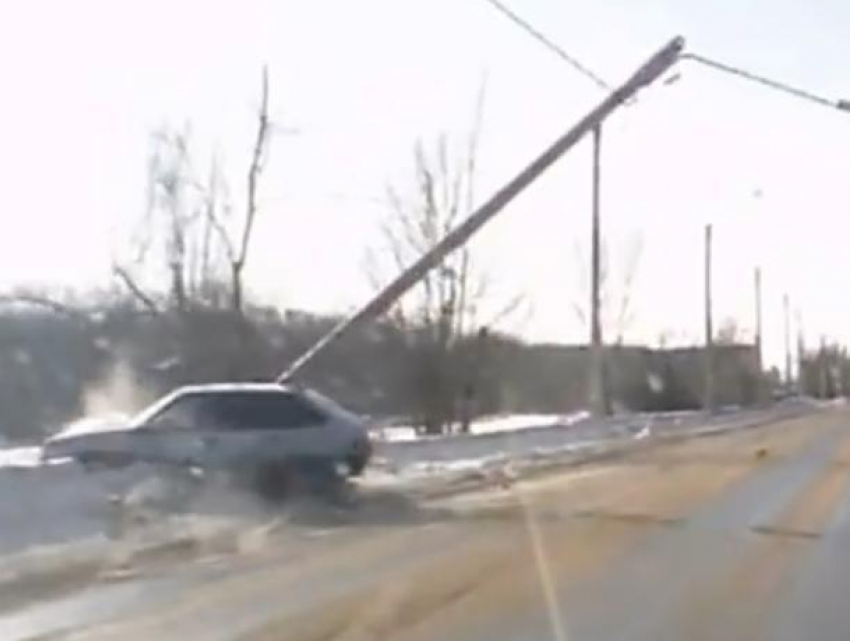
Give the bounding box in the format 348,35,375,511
0,410,850,641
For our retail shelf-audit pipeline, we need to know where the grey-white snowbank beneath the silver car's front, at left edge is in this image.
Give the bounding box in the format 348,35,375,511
0,463,279,591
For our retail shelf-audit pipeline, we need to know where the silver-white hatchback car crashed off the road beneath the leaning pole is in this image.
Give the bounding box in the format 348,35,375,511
42,383,372,476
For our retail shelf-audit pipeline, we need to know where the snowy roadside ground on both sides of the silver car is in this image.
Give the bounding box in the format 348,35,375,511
0,402,824,584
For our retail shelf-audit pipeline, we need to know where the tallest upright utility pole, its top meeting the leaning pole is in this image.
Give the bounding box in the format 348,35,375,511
588,125,608,416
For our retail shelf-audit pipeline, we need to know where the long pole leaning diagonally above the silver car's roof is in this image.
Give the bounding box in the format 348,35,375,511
276,37,685,383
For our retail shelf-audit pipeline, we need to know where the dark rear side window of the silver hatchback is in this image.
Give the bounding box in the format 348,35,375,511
207,393,325,430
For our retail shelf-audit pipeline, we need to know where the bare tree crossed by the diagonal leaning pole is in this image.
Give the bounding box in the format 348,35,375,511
367,85,504,433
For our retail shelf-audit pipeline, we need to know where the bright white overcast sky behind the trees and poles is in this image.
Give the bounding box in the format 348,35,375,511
0,0,850,370
